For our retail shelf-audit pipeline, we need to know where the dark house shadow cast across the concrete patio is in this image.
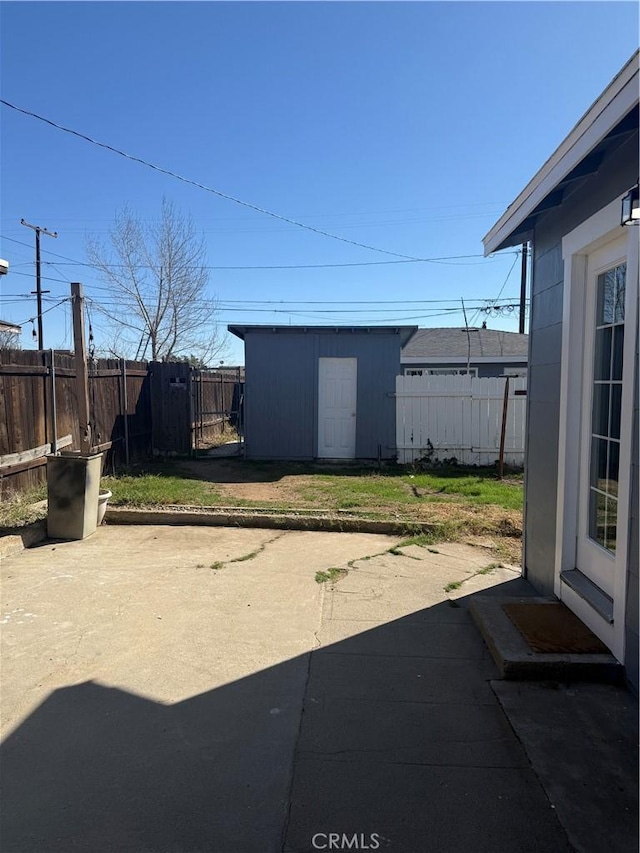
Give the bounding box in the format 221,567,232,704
0,579,637,853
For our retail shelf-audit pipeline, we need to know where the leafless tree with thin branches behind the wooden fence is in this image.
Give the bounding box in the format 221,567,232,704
87,199,224,363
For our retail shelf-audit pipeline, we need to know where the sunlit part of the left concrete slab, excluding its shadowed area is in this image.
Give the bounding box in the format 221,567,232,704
0,526,395,730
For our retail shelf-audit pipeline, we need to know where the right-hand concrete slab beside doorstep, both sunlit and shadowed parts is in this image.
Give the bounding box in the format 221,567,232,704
283,543,584,853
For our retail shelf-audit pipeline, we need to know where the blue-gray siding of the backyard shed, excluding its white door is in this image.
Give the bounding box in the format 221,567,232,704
245,330,400,460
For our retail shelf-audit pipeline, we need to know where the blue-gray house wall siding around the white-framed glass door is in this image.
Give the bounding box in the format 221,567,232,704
524,128,638,689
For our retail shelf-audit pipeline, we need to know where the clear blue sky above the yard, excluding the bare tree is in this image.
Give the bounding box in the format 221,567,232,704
0,2,638,363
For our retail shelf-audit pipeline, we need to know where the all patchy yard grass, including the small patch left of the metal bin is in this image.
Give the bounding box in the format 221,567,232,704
0,458,523,563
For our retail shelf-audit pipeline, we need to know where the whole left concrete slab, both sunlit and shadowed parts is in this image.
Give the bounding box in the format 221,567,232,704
0,526,397,853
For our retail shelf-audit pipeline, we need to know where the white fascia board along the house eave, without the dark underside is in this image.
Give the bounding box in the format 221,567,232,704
482,51,640,257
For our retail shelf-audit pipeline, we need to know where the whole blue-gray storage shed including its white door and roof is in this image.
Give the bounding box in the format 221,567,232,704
228,325,417,460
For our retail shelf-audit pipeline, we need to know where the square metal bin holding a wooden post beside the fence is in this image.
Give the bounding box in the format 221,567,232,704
47,450,103,539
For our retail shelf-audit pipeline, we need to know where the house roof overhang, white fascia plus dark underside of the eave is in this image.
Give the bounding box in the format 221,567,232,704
483,51,640,256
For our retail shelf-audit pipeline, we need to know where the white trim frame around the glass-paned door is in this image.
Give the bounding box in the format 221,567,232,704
554,196,638,661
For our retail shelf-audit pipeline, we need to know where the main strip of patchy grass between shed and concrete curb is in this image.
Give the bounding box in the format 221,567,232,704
103,459,522,515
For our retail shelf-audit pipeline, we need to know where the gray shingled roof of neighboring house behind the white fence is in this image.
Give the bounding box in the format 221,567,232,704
402,328,529,361
